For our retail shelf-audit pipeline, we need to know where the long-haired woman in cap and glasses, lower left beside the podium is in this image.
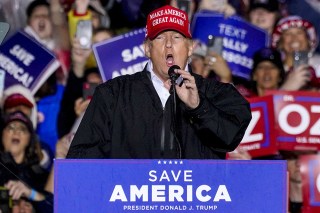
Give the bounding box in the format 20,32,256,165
0,111,53,213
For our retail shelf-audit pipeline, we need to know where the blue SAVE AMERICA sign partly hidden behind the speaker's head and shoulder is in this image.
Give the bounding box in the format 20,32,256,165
92,29,148,81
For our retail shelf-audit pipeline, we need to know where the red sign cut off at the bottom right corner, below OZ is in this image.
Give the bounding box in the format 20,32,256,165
299,155,320,213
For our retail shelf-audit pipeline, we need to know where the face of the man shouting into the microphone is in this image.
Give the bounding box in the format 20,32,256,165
144,31,192,81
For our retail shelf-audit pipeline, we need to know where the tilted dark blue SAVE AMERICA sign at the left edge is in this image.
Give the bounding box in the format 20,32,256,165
0,31,59,94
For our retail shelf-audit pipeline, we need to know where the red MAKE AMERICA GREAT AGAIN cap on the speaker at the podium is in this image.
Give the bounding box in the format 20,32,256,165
145,5,192,40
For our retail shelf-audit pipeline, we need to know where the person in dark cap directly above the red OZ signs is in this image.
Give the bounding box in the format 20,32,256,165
250,47,285,96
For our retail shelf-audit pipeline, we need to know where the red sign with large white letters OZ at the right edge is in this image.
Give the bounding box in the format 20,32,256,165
273,91,320,150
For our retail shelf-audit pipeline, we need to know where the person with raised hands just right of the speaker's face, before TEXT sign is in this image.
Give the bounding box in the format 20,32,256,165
190,40,232,83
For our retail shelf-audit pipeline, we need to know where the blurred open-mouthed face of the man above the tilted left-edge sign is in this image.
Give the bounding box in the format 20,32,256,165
29,6,52,39
